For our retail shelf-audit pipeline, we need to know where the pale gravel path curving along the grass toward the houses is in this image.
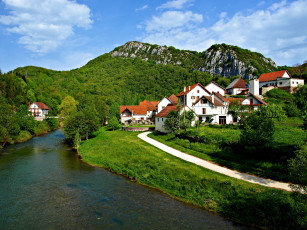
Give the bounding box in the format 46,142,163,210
138,132,291,191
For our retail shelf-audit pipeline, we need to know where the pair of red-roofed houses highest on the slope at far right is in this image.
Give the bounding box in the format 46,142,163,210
226,70,304,95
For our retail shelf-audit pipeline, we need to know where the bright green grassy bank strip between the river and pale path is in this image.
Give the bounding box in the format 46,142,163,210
79,129,307,229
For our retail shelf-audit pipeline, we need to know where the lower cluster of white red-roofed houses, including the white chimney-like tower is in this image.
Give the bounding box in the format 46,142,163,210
120,79,267,132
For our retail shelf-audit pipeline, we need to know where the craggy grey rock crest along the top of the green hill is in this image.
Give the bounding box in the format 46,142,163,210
110,42,277,78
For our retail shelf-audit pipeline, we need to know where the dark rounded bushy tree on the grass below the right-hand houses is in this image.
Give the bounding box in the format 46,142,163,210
240,111,274,148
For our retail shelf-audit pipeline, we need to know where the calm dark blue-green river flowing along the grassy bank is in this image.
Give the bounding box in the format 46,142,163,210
0,130,248,229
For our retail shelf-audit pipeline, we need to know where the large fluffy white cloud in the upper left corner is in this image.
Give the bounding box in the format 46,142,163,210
0,0,92,53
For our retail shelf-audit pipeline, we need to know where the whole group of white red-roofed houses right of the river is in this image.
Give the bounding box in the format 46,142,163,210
120,70,304,133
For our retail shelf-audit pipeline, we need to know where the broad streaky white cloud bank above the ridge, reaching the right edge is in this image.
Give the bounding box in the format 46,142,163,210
140,0,307,65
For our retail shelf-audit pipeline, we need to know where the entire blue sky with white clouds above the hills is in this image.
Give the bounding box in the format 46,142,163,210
0,0,307,72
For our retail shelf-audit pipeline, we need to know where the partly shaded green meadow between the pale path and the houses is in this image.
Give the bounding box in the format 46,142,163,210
149,125,307,182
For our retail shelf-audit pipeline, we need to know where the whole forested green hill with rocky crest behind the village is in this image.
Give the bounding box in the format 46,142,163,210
0,42,296,114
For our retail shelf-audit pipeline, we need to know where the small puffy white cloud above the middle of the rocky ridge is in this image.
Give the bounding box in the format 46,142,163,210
145,11,203,32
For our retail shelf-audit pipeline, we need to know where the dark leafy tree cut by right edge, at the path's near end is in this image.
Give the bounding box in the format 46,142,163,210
289,144,307,193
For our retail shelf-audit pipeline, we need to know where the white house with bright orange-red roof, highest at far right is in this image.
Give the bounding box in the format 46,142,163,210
259,70,305,94
